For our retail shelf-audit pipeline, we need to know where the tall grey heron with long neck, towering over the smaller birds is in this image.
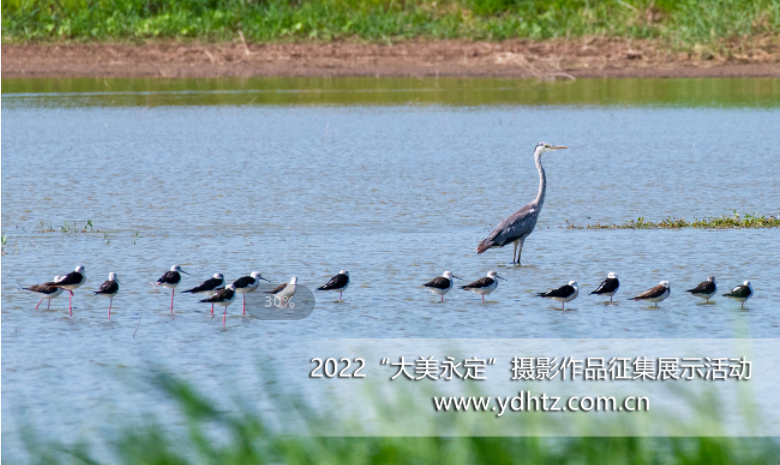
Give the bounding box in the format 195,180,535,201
477,142,569,265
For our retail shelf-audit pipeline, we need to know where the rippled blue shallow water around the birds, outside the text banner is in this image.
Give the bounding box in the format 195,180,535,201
2,79,780,458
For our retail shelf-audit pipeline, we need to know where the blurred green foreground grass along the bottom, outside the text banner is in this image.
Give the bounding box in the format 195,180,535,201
16,377,780,465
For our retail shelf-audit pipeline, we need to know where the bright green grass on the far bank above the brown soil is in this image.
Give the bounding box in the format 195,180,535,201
2,0,780,47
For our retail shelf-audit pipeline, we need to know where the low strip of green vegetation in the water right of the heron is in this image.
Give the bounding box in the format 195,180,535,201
565,211,780,229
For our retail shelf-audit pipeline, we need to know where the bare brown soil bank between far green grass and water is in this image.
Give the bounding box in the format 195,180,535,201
2,38,780,79
